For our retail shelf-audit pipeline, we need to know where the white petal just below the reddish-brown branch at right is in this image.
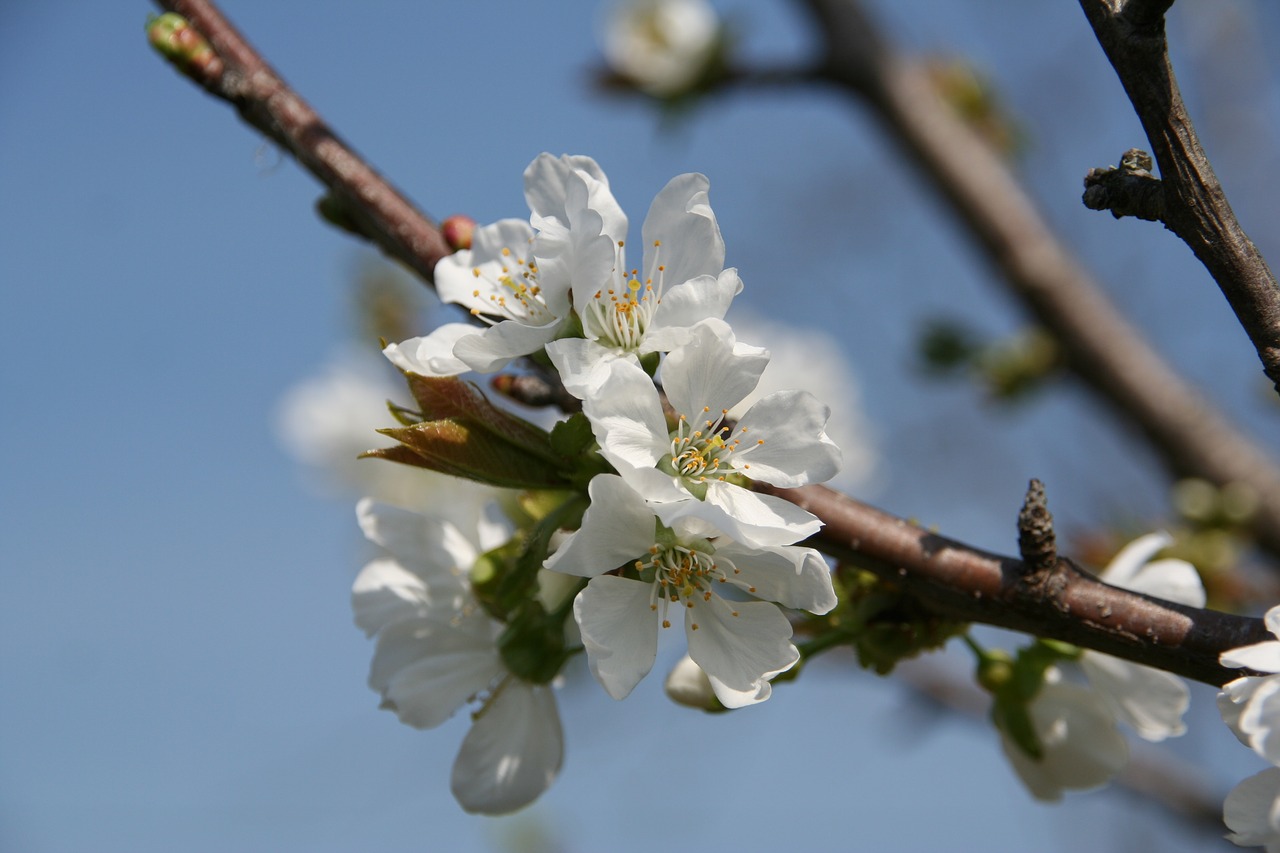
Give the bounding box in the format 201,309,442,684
1080,652,1190,742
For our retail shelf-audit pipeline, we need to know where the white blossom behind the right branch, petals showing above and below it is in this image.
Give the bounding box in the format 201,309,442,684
1080,533,1204,740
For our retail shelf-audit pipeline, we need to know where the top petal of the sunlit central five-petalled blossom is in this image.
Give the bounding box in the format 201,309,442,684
662,319,769,421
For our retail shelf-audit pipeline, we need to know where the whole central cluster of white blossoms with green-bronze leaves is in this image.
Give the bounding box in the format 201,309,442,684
353,154,841,813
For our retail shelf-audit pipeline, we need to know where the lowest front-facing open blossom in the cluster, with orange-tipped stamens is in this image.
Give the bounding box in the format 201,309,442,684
547,474,836,707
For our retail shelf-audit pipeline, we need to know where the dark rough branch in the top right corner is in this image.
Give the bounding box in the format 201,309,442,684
1080,0,1280,393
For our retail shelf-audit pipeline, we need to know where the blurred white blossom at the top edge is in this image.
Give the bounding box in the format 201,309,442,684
604,0,719,97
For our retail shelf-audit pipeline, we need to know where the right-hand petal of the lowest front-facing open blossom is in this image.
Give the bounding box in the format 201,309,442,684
716,542,838,616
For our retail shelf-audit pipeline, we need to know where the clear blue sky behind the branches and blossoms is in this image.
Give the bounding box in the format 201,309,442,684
0,0,1280,853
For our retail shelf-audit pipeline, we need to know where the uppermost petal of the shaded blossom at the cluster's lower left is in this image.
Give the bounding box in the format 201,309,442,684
356,498,479,584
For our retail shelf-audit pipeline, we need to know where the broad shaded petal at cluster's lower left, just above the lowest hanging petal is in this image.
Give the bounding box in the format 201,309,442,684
369,619,504,729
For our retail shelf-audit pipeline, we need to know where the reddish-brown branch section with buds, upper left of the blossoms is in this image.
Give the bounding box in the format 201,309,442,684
156,0,452,283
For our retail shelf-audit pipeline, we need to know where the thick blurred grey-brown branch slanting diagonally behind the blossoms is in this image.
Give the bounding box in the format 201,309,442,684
788,0,1280,555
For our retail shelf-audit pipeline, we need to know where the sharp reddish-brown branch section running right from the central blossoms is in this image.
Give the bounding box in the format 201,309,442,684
754,483,1275,685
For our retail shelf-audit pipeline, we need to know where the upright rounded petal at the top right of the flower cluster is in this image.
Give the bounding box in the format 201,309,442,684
641,173,724,283
